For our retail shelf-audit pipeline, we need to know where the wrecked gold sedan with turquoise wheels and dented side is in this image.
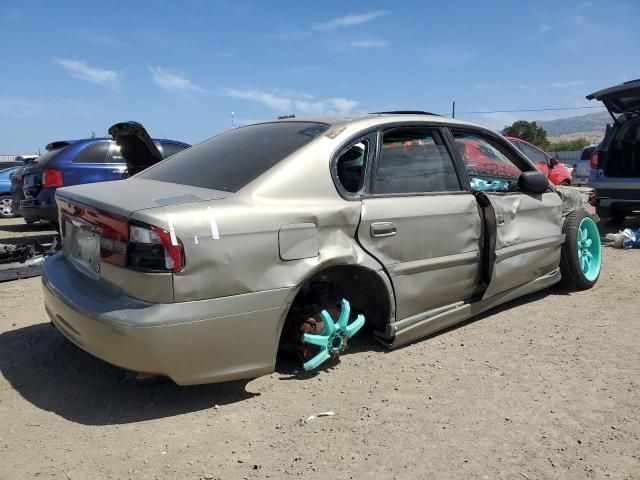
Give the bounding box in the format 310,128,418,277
42,112,601,385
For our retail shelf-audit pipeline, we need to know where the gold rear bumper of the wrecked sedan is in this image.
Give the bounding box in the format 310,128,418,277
42,253,292,385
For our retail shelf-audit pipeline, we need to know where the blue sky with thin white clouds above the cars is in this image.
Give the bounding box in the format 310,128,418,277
0,0,640,154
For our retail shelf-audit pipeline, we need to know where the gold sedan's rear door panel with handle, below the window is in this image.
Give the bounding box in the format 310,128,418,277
358,193,482,320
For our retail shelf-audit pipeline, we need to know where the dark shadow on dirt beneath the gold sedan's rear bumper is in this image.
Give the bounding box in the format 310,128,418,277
0,318,259,425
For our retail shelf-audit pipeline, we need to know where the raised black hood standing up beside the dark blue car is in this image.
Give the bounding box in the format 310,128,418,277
109,122,162,176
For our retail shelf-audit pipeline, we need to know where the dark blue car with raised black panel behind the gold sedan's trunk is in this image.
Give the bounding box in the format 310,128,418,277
18,122,190,224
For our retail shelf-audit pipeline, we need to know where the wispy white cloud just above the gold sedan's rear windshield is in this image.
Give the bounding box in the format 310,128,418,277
227,88,358,115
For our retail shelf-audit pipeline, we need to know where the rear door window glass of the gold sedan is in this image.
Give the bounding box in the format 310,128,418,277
373,127,460,194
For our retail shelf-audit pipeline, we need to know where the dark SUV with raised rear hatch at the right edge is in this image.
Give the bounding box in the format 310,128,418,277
587,80,640,225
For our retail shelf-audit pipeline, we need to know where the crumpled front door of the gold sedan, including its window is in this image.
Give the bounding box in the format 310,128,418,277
452,130,564,298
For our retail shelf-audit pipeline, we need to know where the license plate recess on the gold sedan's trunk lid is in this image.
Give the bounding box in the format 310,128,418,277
63,220,100,276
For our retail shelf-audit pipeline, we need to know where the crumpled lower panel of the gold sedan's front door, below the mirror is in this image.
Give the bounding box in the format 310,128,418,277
483,192,564,298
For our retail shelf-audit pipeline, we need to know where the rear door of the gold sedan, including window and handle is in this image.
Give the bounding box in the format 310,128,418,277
354,125,482,320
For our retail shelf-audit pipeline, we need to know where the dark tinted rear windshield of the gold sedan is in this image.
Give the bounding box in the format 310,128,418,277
138,122,329,192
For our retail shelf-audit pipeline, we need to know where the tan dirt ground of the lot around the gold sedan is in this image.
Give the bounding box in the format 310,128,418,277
0,220,640,480
